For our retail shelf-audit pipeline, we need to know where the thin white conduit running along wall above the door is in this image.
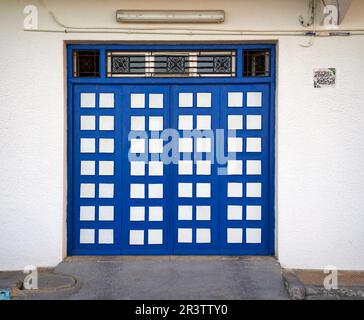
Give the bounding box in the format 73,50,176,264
24,0,364,37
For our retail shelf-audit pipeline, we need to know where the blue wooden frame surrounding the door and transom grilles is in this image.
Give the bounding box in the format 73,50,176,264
67,44,276,256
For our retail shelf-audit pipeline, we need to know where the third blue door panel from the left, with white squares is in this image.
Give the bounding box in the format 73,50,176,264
171,85,220,254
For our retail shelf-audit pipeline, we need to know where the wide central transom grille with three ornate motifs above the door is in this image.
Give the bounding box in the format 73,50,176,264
107,51,236,77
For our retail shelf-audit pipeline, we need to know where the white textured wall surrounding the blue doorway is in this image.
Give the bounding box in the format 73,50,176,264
0,0,364,270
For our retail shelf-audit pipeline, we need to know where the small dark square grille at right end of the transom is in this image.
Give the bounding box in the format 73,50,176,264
244,50,270,77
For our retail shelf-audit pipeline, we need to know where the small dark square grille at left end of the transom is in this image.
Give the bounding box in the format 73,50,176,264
73,50,100,78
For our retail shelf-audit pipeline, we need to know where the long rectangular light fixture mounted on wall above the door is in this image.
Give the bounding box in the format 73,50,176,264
116,10,225,23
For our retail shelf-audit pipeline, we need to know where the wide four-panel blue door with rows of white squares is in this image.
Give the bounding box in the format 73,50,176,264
72,84,272,255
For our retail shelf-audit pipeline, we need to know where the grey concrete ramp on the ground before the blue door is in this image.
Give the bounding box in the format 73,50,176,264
2,257,288,300
